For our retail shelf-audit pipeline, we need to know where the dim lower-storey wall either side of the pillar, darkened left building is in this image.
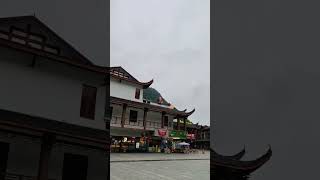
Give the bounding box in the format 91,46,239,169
0,131,109,180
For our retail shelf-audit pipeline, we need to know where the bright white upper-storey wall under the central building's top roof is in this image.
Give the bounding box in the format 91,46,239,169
110,78,143,102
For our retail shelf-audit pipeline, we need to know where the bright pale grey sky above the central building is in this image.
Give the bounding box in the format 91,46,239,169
110,0,210,125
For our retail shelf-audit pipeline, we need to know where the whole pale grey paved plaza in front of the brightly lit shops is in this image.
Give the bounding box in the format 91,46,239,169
110,151,210,180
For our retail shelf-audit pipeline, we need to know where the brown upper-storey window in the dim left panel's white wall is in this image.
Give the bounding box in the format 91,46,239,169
80,85,97,119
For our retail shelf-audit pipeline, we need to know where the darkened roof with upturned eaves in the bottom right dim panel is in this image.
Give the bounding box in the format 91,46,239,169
210,147,272,180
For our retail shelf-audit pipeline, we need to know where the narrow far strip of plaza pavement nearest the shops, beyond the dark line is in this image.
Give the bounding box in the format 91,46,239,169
110,151,210,163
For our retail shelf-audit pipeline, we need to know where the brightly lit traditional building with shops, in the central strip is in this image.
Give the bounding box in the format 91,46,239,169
110,67,195,152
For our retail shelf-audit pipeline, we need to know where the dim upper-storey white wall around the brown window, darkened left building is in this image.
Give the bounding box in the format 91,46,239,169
0,47,106,129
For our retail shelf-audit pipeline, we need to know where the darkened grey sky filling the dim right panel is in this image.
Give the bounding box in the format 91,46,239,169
211,0,320,180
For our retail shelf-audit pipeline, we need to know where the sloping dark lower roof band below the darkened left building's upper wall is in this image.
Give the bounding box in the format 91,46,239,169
0,110,108,143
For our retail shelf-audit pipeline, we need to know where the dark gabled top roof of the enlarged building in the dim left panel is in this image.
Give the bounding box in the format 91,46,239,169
0,16,109,73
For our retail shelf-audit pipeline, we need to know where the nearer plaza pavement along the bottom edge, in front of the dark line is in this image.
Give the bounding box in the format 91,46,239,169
110,160,210,180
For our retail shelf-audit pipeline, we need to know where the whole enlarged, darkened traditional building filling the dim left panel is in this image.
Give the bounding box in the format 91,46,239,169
0,16,109,180
